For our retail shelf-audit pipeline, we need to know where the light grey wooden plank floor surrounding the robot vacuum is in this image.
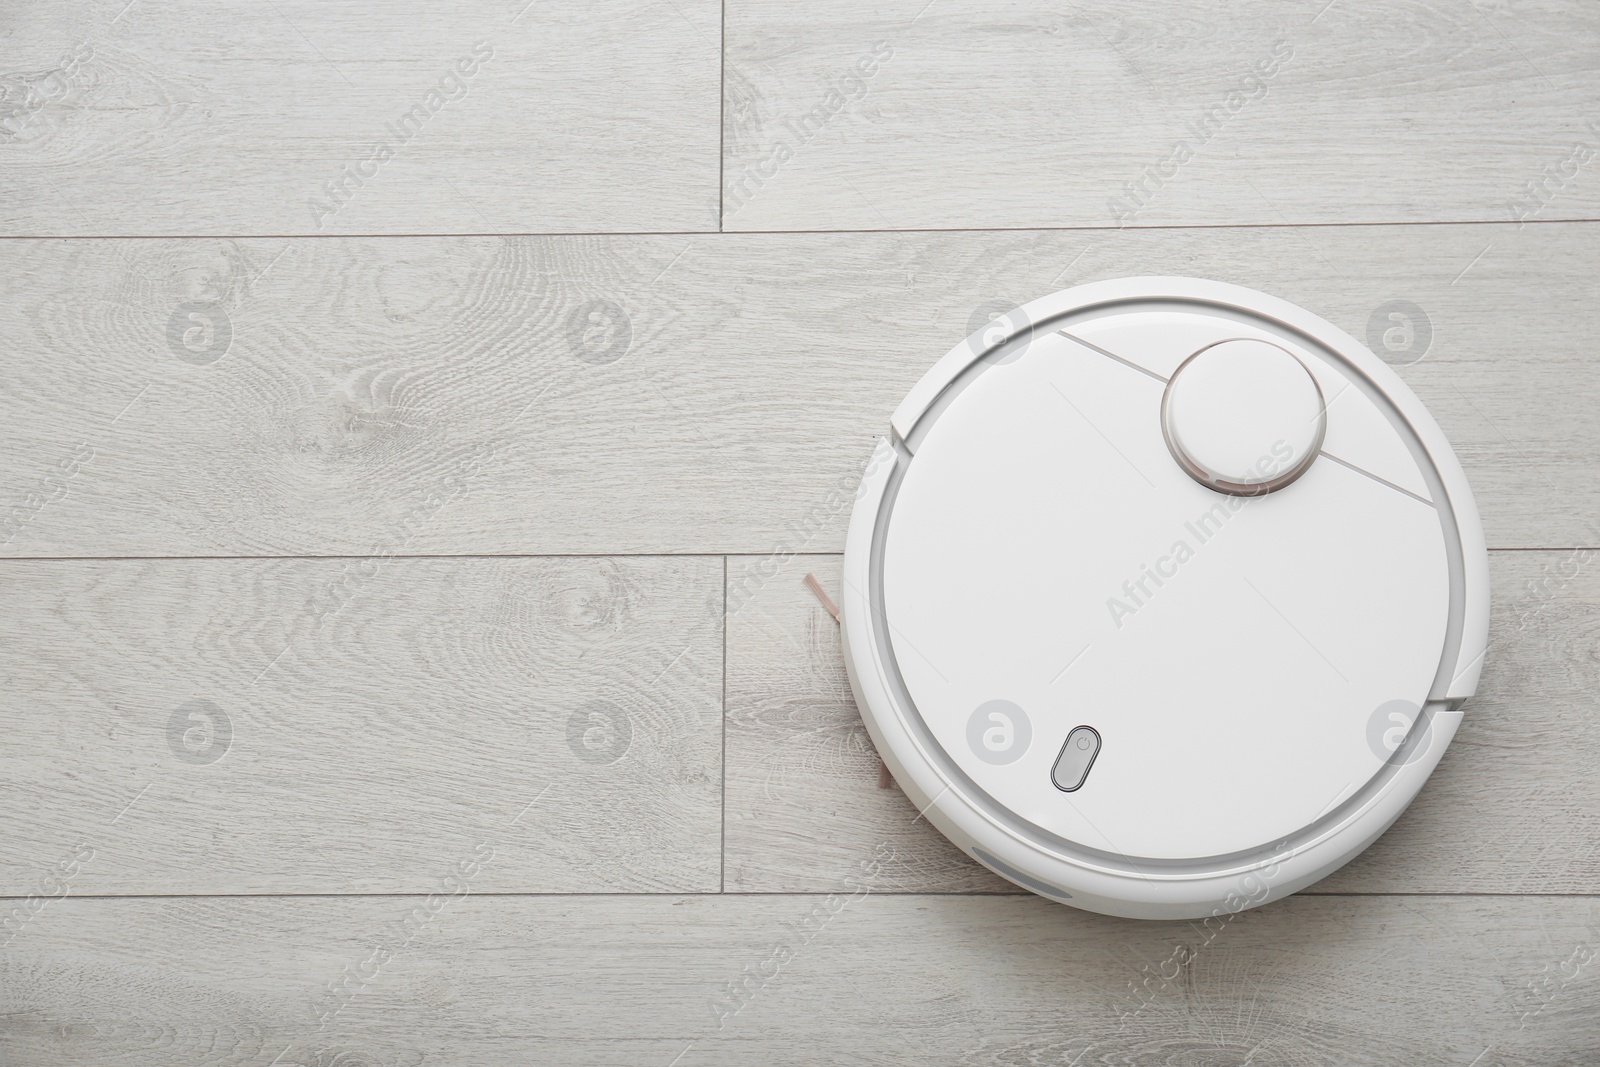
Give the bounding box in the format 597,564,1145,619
0,0,1600,1067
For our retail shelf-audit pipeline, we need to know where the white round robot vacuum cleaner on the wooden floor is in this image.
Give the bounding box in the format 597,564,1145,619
843,278,1490,918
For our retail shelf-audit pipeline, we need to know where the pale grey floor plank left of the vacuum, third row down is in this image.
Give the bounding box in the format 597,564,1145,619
0,558,722,895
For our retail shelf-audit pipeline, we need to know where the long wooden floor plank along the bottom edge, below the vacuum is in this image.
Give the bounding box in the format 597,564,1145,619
0,894,1600,1067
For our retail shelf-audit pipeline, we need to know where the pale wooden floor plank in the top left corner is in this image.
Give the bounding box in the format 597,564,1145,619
0,0,720,235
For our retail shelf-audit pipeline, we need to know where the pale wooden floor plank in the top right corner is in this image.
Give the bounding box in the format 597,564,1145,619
723,0,1600,230
